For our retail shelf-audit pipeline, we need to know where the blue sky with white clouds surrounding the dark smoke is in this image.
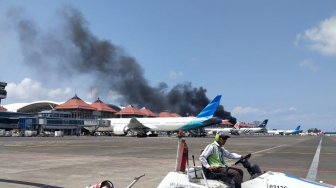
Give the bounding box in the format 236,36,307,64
0,0,336,131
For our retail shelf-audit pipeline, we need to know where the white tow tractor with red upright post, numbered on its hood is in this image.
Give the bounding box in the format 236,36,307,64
157,138,336,188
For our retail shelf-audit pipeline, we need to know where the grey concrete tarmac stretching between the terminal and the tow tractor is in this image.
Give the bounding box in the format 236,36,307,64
0,136,336,188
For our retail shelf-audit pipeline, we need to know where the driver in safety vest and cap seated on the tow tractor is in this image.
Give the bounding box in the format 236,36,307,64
199,132,243,188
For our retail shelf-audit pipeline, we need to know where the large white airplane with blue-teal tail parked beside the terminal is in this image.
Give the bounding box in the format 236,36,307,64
104,95,222,136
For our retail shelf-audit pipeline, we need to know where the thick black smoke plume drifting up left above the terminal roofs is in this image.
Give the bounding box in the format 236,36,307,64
8,8,233,119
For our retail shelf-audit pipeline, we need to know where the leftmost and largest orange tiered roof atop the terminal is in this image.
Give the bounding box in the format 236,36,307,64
55,95,96,111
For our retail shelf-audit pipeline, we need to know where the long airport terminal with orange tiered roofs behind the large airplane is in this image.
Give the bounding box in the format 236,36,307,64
0,87,184,136
